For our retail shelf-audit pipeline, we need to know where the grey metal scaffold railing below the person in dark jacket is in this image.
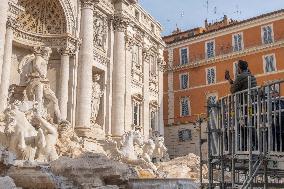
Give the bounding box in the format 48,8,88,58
207,78,284,188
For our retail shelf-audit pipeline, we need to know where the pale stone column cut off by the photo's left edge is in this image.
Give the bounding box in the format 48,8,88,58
0,0,9,83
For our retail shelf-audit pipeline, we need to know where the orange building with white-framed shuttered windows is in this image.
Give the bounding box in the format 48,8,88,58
164,10,284,157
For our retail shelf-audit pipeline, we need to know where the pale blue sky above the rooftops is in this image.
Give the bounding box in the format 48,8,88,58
138,0,284,35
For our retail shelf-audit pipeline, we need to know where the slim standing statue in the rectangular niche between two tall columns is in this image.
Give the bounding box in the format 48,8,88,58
91,74,104,123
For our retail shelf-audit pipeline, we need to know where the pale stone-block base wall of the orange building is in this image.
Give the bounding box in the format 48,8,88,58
165,124,207,159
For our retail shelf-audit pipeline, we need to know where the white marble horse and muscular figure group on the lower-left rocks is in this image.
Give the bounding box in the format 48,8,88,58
4,101,58,162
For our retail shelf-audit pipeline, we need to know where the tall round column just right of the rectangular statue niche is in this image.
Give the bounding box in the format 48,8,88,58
112,16,130,137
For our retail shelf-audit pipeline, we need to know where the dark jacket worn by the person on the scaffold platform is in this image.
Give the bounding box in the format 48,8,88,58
230,71,257,93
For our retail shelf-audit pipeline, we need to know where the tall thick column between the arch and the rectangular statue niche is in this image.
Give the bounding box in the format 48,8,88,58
75,0,97,137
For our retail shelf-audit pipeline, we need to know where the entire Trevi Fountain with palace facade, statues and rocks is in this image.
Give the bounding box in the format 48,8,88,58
0,0,206,189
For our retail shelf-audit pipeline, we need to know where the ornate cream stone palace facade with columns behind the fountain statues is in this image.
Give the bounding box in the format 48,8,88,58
0,0,164,138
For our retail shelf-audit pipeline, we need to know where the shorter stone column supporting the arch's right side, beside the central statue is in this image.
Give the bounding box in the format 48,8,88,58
58,48,71,120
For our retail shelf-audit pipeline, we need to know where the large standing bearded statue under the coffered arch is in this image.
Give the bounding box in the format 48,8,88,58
18,47,61,122
